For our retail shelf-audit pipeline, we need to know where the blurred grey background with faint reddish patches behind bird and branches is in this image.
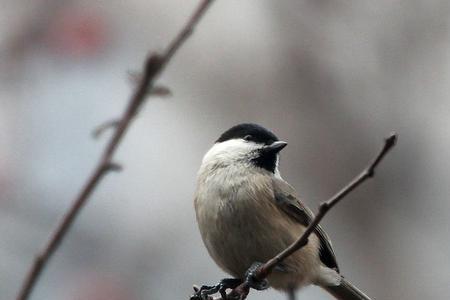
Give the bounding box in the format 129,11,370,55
0,0,450,300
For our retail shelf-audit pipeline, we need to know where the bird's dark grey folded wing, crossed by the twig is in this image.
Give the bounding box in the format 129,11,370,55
273,178,339,272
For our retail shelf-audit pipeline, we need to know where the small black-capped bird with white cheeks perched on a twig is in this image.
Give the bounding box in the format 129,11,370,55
194,124,370,300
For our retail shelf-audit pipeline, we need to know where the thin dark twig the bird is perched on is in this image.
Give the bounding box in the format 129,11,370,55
218,133,397,300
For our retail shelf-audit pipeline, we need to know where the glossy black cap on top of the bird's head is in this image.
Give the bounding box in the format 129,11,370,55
216,123,278,145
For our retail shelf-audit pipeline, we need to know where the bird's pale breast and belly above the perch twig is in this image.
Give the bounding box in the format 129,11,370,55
195,170,299,277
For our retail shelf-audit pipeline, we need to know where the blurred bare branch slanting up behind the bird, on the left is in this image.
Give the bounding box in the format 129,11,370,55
17,0,214,300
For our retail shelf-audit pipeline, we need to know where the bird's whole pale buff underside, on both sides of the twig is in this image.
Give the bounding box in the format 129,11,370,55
195,163,325,290
